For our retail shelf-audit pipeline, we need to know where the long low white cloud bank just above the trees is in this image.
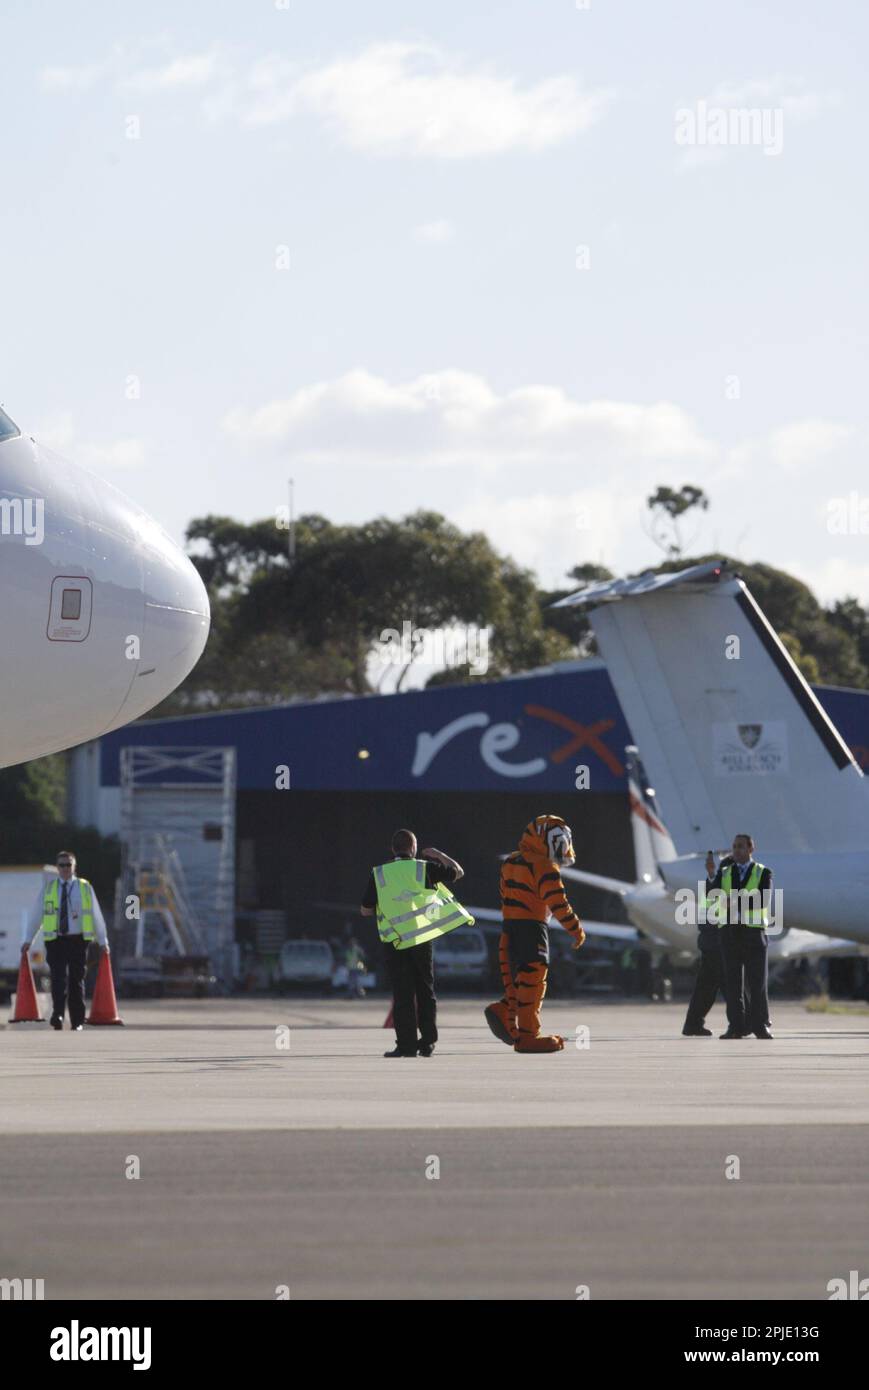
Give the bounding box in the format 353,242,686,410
221,368,865,583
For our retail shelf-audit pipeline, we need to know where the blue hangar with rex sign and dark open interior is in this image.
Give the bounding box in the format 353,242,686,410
99,662,869,931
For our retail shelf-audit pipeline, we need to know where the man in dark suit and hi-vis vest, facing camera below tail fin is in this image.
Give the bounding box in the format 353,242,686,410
706,834,773,1040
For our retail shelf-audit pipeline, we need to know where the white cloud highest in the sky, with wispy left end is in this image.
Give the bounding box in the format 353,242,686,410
40,42,612,158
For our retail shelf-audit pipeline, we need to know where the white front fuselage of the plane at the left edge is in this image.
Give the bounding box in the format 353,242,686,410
0,435,210,767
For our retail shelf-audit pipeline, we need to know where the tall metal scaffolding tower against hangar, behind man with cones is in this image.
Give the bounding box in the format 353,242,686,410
115,745,235,983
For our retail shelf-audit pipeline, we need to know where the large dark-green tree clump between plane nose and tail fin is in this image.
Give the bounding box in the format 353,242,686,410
150,510,573,717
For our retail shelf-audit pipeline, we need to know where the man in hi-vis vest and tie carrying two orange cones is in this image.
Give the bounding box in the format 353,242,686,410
21,849,108,1033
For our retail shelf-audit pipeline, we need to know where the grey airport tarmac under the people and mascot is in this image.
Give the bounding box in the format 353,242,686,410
0,998,869,1301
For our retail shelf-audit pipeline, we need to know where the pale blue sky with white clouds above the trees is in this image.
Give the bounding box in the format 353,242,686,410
0,0,869,603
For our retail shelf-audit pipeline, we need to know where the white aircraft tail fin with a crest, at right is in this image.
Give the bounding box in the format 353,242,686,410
559,563,869,858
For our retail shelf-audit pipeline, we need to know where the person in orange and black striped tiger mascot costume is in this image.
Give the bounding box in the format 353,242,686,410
485,816,585,1052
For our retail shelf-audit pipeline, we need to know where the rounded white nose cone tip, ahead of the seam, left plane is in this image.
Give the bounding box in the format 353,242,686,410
124,516,211,721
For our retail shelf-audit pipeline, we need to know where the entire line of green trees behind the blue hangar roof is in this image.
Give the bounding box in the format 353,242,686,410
152,511,869,717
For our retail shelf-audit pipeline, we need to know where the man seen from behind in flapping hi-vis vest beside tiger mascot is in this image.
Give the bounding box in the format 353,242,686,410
360,830,474,1056
